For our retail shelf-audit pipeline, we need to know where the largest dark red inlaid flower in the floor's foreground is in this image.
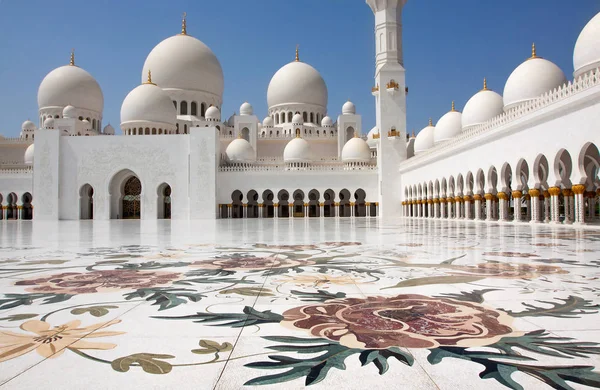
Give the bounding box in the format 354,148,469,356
282,294,514,349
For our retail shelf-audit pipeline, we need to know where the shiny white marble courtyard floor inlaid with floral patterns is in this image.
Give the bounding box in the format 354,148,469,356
0,219,600,390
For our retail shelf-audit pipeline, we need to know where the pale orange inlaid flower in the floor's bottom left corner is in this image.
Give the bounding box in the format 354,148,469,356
0,320,124,362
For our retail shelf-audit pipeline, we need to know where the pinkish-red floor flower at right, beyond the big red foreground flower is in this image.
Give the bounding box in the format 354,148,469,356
451,263,569,279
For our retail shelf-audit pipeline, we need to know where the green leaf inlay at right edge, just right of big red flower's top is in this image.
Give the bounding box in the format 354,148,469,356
504,295,600,318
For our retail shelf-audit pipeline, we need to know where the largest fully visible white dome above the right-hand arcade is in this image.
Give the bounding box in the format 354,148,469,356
504,46,567,111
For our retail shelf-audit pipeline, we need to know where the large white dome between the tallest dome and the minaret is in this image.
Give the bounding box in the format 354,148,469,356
267,61,328,109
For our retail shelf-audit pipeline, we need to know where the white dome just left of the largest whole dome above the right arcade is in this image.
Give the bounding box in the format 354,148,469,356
462,80,504,129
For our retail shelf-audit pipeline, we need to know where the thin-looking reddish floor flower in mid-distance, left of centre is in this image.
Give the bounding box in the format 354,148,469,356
191,256,315,271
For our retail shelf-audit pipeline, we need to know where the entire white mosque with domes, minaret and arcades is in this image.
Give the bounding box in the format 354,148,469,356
0,0,600,224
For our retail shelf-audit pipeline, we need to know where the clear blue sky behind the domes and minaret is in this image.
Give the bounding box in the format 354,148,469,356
0,0,600,136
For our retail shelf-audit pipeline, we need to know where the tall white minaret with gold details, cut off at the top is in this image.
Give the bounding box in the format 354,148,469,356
366,0,407,217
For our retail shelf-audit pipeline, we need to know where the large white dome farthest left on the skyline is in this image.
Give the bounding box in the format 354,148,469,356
38,65,104,114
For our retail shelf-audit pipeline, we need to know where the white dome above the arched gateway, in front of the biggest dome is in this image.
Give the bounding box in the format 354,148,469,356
121,79,177,128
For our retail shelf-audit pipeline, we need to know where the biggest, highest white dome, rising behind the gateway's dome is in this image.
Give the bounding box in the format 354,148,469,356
142,35,224,100
